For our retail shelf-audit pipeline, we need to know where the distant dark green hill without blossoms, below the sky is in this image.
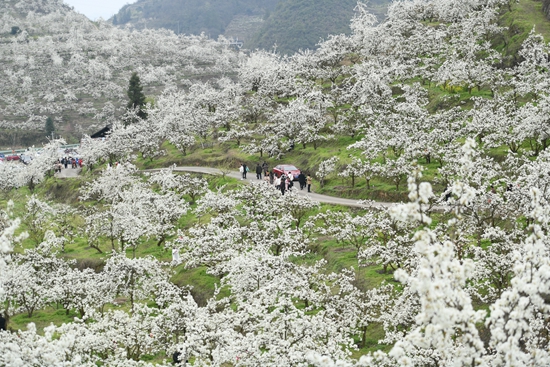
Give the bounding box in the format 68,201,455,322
112,0,389,53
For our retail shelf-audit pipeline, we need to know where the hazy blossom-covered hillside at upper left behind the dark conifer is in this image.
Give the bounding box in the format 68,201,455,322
0,0,244,149
